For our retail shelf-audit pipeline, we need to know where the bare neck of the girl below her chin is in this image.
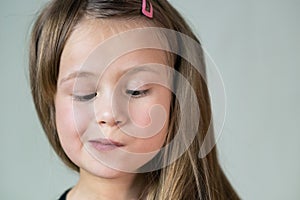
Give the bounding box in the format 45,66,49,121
68,169,143,200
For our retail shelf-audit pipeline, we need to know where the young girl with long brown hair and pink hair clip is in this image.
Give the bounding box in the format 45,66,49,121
30,0,239,200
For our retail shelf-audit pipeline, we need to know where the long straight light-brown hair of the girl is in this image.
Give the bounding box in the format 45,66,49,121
29,0,239,200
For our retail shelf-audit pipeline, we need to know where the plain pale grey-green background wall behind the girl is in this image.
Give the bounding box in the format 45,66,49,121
0,0,300,200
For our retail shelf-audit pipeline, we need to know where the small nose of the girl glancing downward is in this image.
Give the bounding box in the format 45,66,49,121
94,90,126,127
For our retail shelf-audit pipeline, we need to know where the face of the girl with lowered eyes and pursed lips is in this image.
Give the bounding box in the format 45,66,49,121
55,20,171,177
